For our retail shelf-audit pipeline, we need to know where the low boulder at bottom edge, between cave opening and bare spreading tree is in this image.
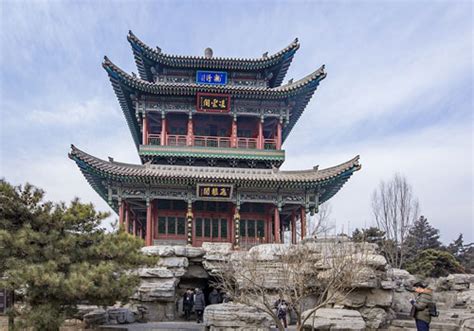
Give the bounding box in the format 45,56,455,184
204,302,273,330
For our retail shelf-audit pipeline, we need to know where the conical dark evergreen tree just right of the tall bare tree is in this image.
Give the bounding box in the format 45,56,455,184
405,216,441,264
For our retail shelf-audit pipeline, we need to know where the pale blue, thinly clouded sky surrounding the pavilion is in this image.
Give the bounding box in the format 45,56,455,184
0,0,474,242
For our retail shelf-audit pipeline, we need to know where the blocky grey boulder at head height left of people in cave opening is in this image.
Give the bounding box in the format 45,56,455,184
132,278,179,302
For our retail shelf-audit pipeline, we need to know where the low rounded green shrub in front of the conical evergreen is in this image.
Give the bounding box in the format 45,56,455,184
406,249,464,277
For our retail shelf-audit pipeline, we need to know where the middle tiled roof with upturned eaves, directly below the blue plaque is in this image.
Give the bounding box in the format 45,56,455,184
102,57,326,148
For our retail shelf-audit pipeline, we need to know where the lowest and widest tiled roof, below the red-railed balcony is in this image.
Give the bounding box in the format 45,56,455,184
69,145,361,208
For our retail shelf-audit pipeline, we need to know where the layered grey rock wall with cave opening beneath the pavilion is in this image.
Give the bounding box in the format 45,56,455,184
133,240,474,330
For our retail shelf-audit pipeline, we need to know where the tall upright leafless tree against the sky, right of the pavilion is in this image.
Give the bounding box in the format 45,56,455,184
372,174,419,268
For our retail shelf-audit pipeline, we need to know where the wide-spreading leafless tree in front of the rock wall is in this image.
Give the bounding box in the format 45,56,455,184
210,241,371,330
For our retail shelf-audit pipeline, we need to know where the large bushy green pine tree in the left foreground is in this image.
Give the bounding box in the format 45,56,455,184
0,180,155,330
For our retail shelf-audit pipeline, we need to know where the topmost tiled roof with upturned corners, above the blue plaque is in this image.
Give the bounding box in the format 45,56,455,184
127,31,300,87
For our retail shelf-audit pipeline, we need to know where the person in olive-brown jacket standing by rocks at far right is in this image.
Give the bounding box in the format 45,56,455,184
410,282,433,331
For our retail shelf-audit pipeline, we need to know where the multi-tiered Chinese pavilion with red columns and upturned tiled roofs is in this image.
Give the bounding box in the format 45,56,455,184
69,32,360,248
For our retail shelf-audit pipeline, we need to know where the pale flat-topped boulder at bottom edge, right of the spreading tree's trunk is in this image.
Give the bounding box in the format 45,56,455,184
303,308,366,331
